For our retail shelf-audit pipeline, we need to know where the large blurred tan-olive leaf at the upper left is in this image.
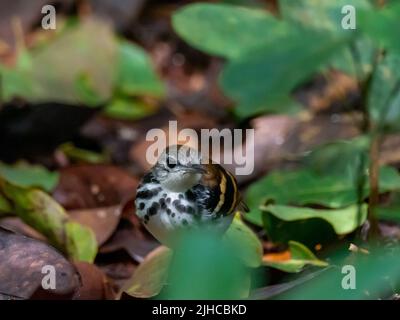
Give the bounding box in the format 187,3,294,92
1,19,117,105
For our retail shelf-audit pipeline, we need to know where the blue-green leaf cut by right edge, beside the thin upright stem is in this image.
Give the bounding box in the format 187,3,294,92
368,53,400,130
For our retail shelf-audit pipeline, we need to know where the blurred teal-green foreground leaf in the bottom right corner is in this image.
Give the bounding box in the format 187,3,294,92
277,245,400,300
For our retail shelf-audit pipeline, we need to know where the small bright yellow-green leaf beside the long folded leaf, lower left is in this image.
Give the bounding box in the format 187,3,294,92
64,221,97,263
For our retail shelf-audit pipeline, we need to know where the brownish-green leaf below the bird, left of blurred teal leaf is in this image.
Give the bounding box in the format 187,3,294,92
122,246,172,298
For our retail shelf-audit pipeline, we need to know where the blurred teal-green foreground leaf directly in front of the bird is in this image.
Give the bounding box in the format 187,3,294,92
162,229,251,299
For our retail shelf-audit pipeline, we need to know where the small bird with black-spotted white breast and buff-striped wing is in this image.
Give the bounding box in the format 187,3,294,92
135,145,248,245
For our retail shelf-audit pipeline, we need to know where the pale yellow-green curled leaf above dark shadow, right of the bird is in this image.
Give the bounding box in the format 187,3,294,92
261,205,367,235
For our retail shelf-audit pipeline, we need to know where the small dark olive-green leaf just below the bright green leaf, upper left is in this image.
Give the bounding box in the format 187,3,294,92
103,96,157,120
